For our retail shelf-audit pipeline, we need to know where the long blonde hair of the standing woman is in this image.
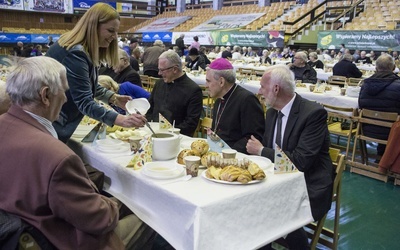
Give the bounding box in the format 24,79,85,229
58,3,120,67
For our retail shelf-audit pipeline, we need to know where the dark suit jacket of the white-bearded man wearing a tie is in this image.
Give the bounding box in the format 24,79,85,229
262,95,334,220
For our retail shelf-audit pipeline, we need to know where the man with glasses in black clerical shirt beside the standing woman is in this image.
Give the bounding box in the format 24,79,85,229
146,51,203,136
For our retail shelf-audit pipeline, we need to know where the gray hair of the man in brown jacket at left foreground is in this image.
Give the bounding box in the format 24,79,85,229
6,56,68,106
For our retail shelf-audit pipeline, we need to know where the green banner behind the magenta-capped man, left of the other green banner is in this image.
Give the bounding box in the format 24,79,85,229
211,31,284,48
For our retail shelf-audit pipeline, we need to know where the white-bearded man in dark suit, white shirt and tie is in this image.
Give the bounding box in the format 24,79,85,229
246,65,334,249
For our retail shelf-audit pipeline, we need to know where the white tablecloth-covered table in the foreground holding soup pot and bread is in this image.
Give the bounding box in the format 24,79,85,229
68,128,313,250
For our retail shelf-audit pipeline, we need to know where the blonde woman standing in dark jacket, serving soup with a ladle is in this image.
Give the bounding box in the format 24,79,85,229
46,3,146,142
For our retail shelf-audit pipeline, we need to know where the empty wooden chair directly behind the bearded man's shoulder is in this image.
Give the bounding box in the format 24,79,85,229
323,104,358,159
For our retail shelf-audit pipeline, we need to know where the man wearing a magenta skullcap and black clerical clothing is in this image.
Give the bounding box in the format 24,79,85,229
206,58,264,153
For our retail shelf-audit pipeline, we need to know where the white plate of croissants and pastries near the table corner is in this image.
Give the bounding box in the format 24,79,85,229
205,155,266,184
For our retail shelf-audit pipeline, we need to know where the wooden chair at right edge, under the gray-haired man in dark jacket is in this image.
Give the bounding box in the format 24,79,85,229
347,109,399,182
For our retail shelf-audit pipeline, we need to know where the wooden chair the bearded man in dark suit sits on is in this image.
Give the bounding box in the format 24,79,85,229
306,148,346,250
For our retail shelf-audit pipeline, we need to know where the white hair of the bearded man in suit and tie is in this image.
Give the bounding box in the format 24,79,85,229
264,65,296,94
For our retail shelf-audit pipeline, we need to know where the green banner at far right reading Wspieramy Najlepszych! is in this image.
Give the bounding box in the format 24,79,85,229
318,30,400,51
